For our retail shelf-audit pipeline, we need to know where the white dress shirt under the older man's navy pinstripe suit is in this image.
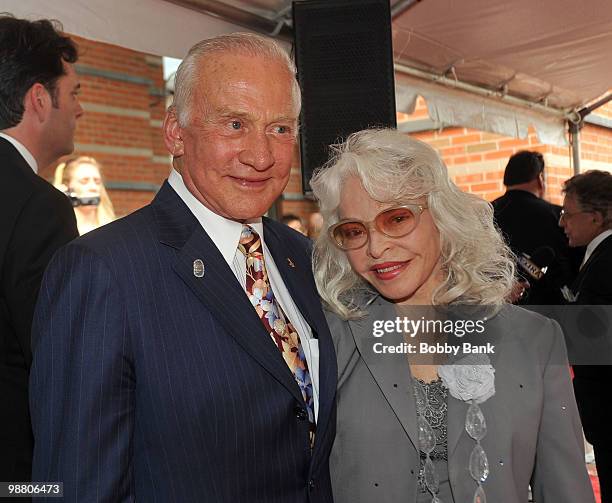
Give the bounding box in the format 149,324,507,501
168,169,319,420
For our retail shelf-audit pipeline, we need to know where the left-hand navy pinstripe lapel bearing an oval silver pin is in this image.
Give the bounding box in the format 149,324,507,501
154,182,303,402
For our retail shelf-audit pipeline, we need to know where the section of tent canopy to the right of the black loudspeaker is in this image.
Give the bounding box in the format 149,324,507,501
393,0,612,144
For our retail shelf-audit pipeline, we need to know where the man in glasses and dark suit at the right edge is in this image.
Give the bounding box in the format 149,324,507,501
559,171,612,503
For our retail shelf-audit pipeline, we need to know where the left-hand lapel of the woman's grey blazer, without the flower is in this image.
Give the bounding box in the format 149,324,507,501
349,304,419,451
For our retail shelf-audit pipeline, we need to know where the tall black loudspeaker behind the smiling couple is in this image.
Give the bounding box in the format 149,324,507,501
293,0,397,192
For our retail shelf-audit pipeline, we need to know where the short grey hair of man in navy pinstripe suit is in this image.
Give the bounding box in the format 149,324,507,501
172,32,302,127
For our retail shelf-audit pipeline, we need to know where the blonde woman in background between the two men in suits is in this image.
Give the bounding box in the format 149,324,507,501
53,155,116,235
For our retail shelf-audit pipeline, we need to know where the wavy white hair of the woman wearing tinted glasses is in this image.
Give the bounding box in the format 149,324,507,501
310,129,514,318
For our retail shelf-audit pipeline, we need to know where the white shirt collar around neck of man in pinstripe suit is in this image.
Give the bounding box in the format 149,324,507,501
168,169,263,266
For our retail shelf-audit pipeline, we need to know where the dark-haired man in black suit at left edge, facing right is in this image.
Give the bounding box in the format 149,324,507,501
0,15,82,488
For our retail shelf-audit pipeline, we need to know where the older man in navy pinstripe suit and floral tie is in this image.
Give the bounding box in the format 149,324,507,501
31,34,336,503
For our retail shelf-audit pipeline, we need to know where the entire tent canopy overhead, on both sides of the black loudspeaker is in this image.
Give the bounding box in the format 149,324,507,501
3,0,612,144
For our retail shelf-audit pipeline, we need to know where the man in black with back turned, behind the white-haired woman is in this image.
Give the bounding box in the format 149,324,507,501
493,151,573,305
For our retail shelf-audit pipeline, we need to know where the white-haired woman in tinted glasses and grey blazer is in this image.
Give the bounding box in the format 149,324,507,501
311,130,593,503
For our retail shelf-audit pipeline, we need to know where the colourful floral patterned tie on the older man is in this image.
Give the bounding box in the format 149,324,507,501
238,225,316,446
